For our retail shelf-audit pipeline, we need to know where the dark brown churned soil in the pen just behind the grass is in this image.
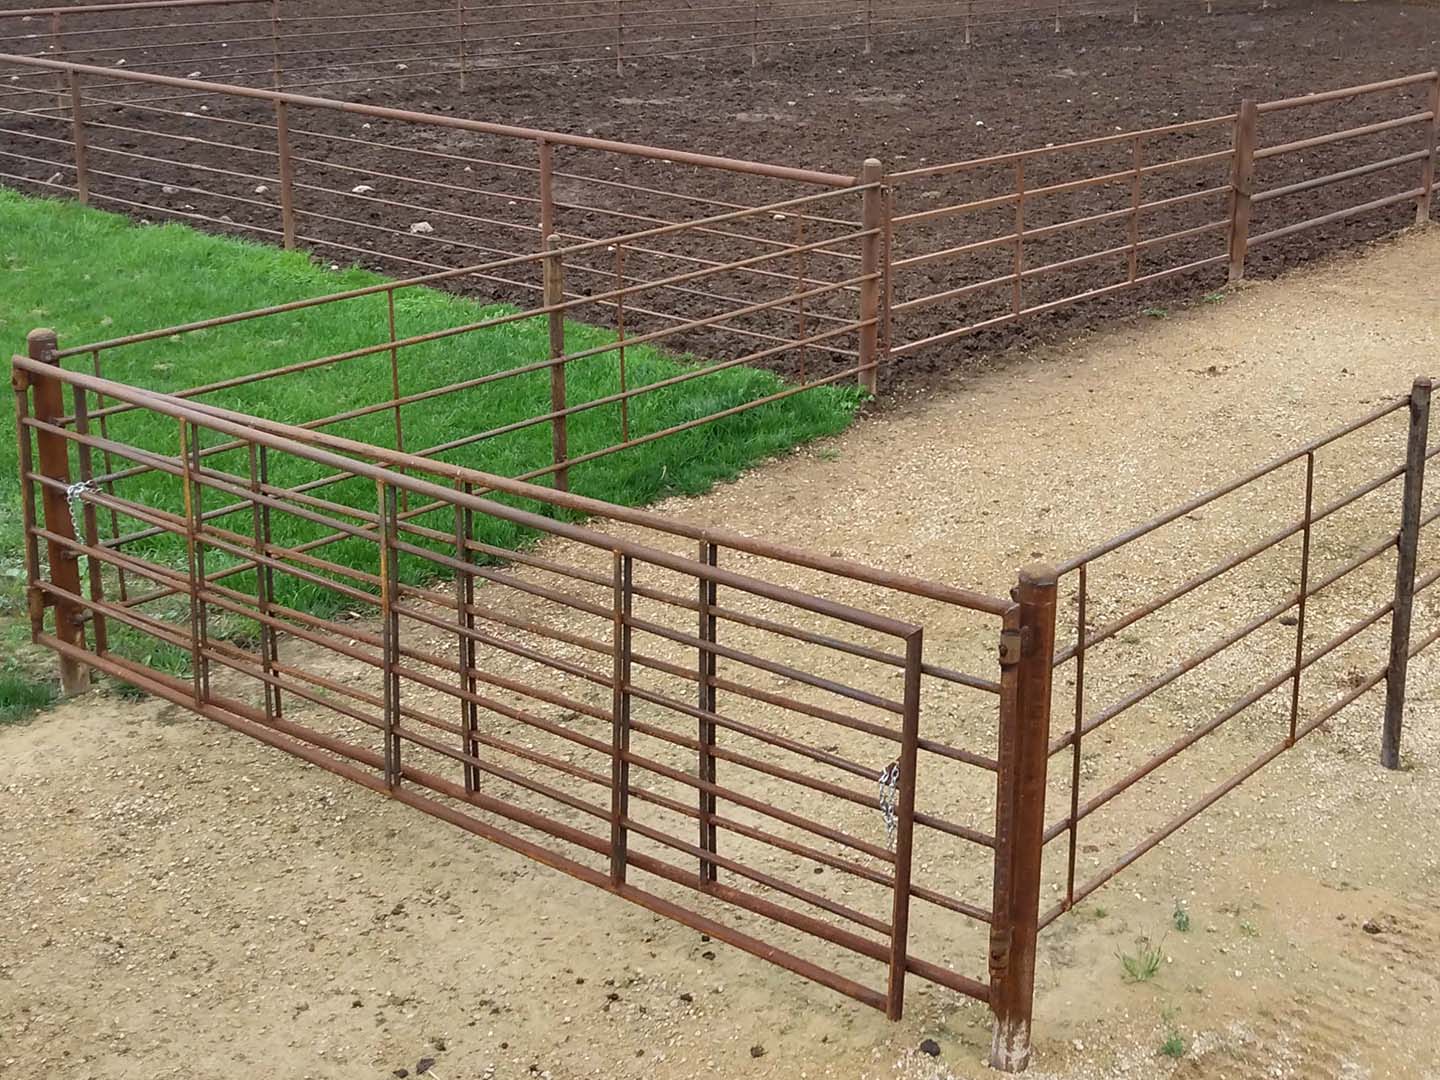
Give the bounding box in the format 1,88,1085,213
8,0,1440,384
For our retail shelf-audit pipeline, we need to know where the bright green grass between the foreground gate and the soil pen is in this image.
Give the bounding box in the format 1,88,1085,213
0,189,861,694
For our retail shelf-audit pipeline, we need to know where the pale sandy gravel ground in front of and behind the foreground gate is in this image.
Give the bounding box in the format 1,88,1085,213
8,232,1440,1080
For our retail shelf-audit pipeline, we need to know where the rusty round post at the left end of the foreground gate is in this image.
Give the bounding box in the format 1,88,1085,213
22,330,89,694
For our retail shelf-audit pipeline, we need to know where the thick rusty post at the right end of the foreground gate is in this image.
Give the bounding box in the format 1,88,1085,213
991,566,1056,1073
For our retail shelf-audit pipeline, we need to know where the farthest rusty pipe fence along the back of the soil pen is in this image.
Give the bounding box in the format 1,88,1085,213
0,0,1273,89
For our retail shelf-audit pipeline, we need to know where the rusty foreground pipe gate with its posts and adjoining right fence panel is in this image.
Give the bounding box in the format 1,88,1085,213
13,339,1440,1071
